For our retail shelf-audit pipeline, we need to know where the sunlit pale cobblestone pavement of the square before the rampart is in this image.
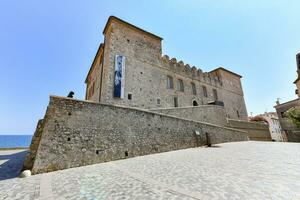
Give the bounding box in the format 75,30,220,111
0,142,300,200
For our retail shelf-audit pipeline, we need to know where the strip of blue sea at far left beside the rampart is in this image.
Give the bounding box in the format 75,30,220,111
0,135,32,148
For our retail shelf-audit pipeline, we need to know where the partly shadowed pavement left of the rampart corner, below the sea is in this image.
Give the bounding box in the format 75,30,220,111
0,150,28,181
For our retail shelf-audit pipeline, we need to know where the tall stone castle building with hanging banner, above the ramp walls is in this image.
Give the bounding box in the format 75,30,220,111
85,16,248,120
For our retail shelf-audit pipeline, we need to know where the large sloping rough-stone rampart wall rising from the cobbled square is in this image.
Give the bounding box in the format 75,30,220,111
28,96,248,174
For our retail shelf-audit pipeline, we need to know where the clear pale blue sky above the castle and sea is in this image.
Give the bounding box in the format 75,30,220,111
0,0,300,134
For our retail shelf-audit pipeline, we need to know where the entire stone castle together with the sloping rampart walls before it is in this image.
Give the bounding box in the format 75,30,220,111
24,17,271,174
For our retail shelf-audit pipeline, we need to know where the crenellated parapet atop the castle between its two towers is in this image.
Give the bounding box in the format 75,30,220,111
161,55,222,86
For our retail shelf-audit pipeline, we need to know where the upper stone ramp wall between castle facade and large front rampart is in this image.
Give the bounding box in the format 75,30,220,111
151,105,227,126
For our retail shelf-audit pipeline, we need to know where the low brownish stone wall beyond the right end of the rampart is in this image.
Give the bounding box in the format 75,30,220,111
227,119,272,141
